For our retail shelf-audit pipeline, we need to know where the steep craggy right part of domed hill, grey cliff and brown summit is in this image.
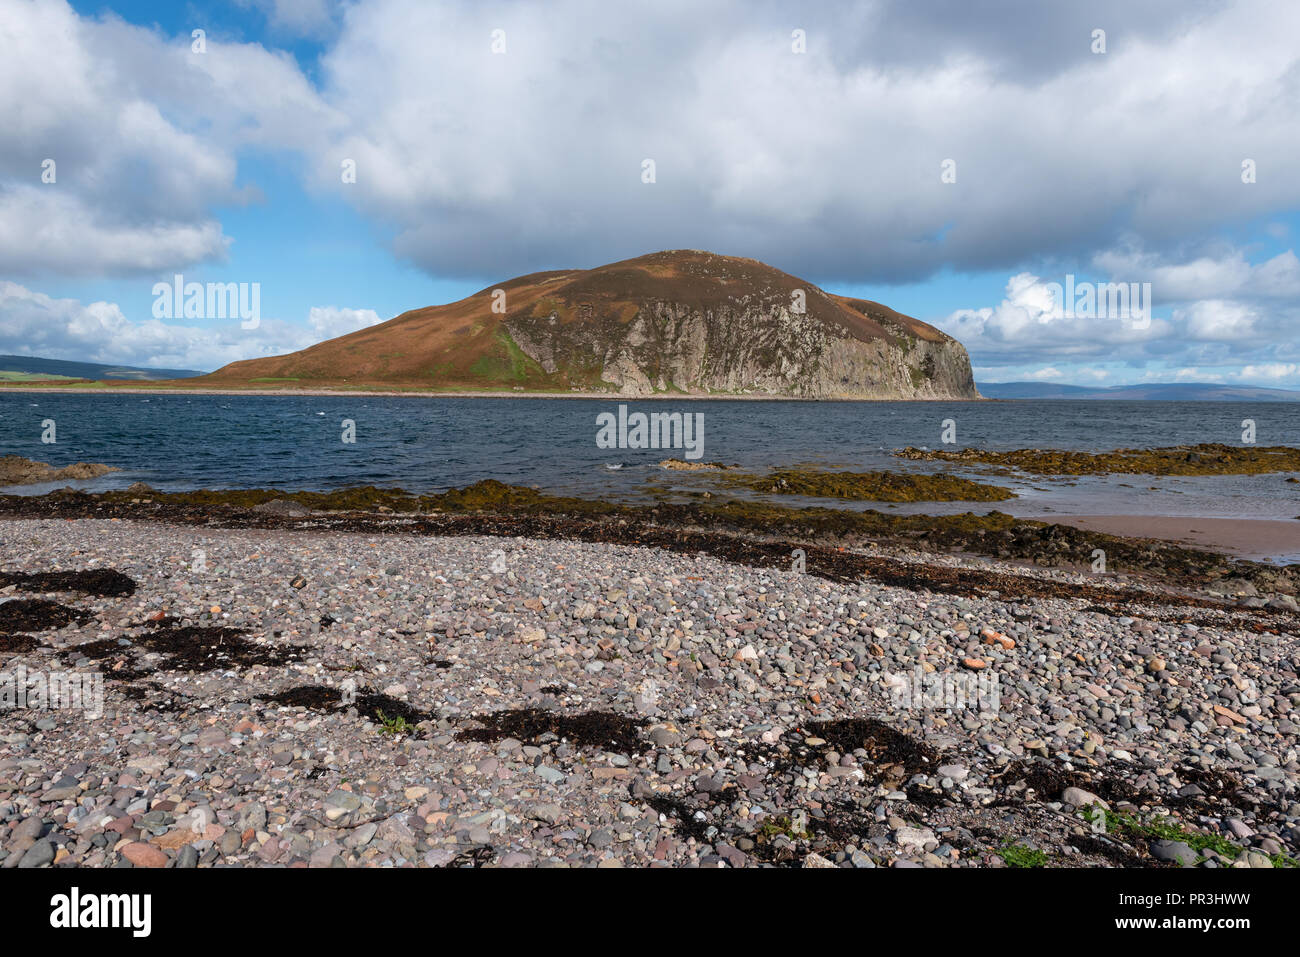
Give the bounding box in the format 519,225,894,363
506,251,979,399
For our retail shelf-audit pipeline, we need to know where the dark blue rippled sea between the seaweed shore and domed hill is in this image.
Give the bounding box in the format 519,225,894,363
0,393,1300,519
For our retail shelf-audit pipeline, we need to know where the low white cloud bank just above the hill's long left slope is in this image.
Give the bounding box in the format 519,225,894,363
0,281,380,372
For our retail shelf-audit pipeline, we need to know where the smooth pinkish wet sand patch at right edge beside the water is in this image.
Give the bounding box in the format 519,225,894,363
1026,512,1300,563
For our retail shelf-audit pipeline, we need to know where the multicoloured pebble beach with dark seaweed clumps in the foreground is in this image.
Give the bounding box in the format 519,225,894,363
0,518,1300,869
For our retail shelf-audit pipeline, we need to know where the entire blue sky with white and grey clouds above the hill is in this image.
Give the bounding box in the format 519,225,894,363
0,0,1300,389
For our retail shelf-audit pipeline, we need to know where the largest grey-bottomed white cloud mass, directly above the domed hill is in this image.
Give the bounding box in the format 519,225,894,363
301,0,1300,281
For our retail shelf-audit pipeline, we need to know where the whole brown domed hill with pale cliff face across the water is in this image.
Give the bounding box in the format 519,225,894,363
200,251,979,399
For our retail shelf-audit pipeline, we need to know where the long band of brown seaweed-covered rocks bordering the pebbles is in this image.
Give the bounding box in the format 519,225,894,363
0,480,1300,594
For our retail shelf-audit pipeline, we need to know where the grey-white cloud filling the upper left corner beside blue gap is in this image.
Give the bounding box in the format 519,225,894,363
0,0,332,277
